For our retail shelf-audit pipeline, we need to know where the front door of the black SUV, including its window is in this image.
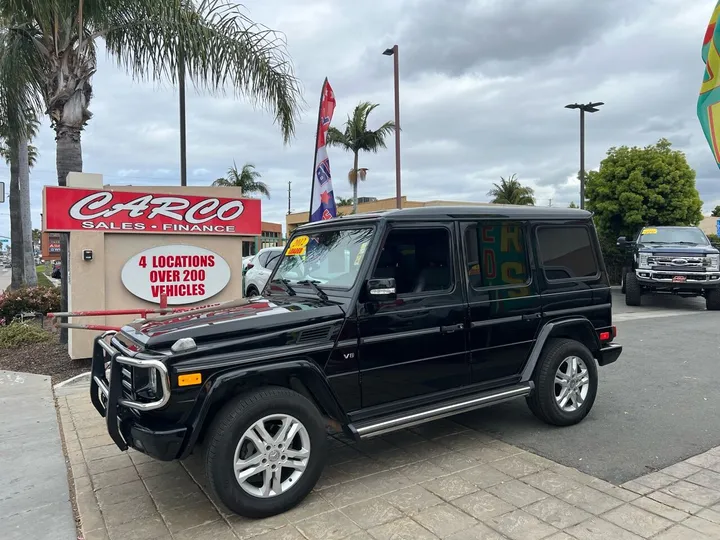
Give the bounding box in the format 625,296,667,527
358,223,470,408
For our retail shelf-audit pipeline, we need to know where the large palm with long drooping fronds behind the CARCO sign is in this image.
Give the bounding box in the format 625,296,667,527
0,0,301,342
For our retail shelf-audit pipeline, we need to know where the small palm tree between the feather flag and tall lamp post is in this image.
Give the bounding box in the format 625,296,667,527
326,101,395,214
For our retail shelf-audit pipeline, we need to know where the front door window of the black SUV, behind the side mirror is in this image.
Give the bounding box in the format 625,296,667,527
373,228,453,295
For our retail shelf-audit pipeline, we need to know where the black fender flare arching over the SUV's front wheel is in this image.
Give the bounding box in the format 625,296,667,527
179,359,348,459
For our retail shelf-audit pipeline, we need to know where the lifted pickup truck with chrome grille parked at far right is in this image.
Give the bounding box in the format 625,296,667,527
617,226,720,310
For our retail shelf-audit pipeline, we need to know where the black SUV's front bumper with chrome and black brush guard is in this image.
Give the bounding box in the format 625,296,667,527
90,332,187,461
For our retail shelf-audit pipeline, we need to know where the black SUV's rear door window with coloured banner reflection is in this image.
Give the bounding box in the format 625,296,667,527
465,221,530,289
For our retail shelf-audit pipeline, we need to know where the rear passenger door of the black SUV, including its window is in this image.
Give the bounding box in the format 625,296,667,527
461,219,542,386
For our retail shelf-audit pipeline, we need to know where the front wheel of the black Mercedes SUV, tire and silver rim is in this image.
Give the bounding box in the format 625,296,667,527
205,387,327,518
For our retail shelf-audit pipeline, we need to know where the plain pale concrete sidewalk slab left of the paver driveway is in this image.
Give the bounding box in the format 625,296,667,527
0,371,77,540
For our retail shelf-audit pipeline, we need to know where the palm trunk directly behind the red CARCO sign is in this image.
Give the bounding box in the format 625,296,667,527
55,125,82,343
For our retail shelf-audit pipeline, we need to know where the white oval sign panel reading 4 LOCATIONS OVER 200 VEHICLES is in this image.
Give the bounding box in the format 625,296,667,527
121,244,230,306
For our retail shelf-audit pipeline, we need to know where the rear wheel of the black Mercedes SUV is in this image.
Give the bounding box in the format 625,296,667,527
526,339,598,426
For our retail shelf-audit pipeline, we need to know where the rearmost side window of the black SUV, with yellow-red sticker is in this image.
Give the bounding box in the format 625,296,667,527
537,226,599,281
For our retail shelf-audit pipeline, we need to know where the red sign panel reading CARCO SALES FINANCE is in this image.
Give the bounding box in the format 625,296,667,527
43,186,262,236
